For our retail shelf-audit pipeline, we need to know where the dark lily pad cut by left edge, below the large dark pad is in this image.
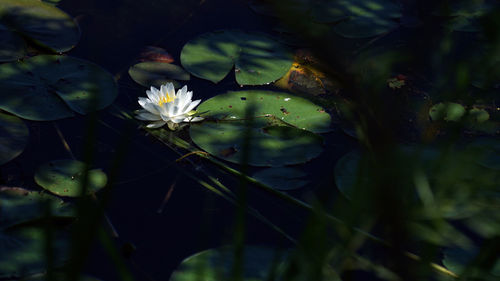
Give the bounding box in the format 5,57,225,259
0,113,29,165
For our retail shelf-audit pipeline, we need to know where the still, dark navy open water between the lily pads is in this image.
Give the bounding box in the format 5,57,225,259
2,0,354,280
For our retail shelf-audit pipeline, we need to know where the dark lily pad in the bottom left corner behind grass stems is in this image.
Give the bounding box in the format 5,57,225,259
0,227,69,279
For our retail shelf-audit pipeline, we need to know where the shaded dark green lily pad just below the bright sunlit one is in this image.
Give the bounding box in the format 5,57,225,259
190,121,323,166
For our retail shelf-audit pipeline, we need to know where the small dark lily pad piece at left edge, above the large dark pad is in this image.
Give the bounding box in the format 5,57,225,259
0,23,26,62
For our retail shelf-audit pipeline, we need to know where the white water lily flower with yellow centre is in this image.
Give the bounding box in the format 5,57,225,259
136,83,203,128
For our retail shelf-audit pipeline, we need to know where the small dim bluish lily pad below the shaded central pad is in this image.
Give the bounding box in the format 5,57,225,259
253,167,309,190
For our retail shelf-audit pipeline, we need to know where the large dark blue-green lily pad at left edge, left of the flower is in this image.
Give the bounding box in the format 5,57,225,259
0,55,117,121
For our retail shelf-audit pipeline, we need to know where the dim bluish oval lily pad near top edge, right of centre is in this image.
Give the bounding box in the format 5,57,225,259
334,17,398,38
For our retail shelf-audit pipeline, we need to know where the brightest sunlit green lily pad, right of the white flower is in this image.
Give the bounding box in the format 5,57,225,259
197,90,330,133
